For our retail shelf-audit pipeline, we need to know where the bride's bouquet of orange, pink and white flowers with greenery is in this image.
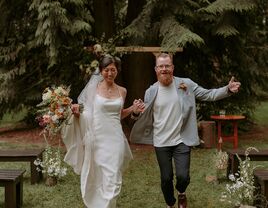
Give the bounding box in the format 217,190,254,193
37,86,72,136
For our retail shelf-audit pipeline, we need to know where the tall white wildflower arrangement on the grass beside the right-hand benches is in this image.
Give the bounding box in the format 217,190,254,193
220,147,258,206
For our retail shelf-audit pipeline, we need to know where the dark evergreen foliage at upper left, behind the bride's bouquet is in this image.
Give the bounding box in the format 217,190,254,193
0,0,93,117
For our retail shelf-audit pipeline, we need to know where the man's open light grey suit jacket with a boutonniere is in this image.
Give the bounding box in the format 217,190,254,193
130,77,231,146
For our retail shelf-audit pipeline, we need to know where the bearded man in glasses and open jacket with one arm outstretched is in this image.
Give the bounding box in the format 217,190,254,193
130,53,241,208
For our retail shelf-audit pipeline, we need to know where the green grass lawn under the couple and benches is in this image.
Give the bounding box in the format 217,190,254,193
0,103,268,208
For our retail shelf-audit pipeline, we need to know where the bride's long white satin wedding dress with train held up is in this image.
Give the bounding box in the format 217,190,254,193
62,76,132,208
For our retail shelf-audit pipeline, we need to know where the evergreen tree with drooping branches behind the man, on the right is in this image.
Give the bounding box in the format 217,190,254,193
120,0,268,119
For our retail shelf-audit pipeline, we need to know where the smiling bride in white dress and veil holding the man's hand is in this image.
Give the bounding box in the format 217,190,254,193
62,55,144,208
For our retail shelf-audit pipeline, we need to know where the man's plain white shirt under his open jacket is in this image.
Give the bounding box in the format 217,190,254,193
153,82,182,147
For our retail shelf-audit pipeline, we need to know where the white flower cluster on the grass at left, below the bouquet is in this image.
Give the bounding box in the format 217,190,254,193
34,146,67,178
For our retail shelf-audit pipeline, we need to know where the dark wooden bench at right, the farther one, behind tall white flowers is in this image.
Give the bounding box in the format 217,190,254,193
226,149,268,178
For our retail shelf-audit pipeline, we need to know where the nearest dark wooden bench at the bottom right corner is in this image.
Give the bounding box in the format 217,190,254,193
253,169,268,207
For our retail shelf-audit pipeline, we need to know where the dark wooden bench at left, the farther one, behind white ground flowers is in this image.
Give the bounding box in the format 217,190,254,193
0,149,44,184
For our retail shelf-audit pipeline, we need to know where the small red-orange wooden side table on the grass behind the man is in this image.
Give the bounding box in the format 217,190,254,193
210,115,245,150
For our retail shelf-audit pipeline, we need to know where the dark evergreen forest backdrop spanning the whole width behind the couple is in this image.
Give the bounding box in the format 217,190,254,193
0,0,268,127
